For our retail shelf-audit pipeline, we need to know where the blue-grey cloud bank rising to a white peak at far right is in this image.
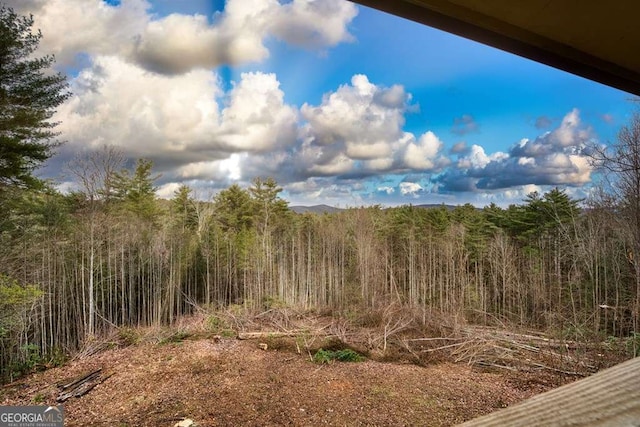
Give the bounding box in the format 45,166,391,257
434,109,593,192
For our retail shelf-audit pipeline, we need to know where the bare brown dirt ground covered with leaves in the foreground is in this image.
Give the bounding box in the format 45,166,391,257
0,336,566,427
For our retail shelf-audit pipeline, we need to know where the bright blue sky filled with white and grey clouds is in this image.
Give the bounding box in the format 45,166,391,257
5,0,635,206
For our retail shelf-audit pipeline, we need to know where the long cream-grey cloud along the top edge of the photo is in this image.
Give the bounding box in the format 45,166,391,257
15,0,357,75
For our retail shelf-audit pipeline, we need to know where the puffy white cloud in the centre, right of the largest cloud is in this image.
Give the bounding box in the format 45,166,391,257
298,75,413,174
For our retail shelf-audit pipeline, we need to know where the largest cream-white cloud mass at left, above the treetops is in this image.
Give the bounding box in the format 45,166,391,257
56,56,297,186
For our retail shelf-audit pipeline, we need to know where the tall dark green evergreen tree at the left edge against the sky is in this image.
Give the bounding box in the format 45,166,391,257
0,6,70,194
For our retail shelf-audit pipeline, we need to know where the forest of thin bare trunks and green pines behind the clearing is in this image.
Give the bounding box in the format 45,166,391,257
0,3,640,381
